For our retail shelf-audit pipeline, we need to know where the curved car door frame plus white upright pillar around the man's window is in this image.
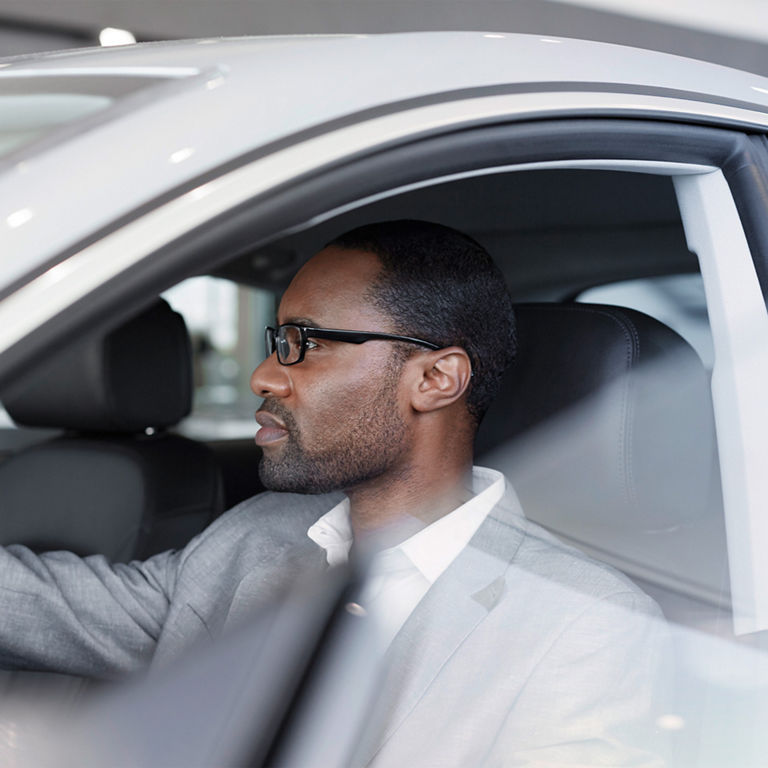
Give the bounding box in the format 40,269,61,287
0,112,768,631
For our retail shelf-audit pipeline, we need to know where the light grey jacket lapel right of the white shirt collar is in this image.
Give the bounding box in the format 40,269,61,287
359,493,523,764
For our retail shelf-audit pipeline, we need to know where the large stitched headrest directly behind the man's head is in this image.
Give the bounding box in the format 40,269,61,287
476,304,717,528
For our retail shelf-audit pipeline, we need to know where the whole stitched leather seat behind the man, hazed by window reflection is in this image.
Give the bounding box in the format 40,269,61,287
476,303,730,631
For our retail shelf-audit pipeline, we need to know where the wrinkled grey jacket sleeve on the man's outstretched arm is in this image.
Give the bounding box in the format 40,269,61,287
0,545,182,677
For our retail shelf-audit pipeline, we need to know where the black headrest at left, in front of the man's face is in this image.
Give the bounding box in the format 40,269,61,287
0,299,192,433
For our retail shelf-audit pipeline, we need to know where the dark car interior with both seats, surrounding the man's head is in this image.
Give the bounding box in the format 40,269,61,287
0,169,733,700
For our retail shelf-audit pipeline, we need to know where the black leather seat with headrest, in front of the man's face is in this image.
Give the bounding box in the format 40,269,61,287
0,300,223,561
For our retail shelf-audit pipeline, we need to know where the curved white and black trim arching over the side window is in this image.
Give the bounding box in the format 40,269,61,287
0,117,752,367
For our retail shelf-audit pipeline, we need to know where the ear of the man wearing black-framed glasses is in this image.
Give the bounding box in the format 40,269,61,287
411,347,472,413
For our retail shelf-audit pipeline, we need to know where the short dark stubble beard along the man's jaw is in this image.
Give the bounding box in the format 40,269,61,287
259,372,406,493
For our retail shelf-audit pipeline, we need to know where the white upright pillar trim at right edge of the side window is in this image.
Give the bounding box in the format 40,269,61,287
673,170,768,634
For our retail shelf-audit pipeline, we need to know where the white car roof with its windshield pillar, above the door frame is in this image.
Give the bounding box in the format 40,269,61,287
0,32,768,286
